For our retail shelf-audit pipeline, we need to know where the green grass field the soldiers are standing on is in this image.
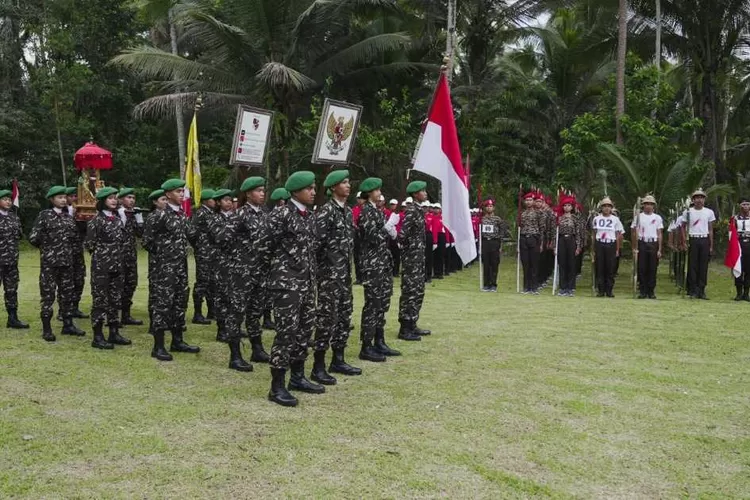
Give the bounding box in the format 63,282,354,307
0,251,750,498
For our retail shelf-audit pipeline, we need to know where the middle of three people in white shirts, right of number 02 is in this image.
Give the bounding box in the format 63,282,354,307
630,195,664,299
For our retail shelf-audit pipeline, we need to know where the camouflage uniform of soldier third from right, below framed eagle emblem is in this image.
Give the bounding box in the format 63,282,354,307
313,199,354,351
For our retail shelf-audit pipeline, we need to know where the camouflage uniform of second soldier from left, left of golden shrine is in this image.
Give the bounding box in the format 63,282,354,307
29,209,80,320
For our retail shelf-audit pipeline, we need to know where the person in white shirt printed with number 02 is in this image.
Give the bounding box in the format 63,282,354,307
592,197,624,297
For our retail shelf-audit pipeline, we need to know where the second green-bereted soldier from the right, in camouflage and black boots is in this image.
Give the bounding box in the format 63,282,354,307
357,177,401,362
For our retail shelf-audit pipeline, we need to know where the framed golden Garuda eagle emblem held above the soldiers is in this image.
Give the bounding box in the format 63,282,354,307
312,99,362,165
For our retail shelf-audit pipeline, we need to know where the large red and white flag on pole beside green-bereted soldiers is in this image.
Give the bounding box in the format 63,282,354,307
414,75,477,264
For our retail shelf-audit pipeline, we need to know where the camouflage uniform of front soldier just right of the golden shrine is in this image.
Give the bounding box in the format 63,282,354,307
84,211,130,326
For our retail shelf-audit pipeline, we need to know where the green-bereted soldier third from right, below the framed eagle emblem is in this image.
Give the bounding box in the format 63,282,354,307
310,170,362,385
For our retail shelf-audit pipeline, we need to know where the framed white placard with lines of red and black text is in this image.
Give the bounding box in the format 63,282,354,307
229,104,273,167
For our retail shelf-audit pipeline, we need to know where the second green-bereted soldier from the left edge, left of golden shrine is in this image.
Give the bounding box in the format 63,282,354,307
29,186,86,342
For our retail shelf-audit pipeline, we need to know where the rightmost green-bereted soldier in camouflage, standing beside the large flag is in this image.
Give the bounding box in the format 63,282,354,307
398,181,431,341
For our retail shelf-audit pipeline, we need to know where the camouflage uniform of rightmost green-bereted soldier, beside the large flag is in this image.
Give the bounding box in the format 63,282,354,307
398,203,425,323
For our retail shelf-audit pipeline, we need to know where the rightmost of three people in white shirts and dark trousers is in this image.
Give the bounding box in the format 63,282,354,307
682,189,716,300
